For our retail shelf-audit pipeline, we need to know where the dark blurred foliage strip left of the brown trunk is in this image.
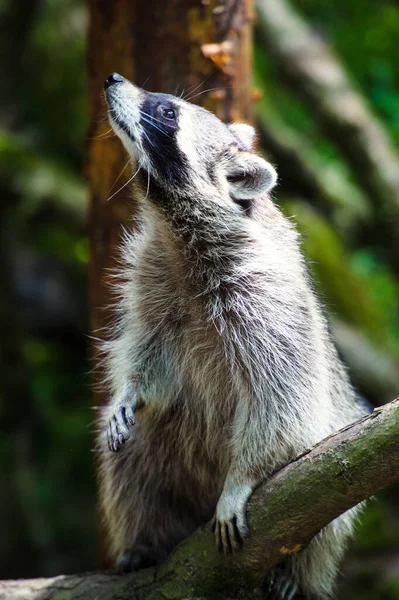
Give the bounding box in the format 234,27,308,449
0,0,93,577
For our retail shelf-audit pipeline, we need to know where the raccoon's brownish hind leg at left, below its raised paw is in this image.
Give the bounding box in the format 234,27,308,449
98,423,203,572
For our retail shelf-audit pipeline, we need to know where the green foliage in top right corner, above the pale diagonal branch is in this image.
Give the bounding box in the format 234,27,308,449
294,0,399,142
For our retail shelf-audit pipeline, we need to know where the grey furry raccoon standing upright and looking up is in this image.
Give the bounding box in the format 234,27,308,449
98,81,363,598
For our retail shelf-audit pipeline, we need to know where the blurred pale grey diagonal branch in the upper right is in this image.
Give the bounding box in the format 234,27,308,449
256,0,399,272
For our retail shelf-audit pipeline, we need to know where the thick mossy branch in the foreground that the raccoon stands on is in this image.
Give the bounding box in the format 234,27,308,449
0,399,399,600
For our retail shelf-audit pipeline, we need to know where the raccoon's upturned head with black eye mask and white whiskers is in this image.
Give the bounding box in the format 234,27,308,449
104,73,277,212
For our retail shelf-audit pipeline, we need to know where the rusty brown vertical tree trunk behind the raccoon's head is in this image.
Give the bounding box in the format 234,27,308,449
86,0,253,568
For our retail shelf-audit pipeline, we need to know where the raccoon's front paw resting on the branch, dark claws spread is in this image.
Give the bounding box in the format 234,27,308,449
212,485,252,554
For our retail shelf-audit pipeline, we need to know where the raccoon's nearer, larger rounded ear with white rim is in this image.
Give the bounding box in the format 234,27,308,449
226,152,277,199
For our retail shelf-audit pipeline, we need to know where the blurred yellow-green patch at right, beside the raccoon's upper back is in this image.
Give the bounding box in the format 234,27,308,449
283,201,399,356
